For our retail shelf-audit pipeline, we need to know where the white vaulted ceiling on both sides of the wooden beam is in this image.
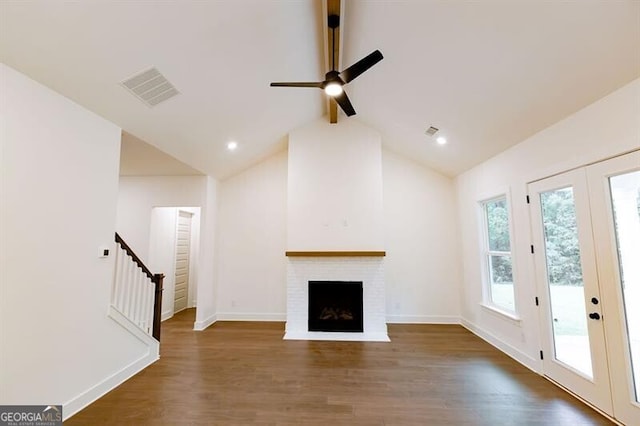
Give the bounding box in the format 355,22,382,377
0,0,640,178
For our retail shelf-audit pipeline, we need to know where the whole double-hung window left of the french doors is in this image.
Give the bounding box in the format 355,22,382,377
482,196,516,314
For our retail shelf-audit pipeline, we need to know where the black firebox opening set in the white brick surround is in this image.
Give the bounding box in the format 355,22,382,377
309,281,364,333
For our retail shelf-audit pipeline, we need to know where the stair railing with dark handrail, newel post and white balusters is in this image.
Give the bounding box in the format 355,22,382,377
111,232,164,342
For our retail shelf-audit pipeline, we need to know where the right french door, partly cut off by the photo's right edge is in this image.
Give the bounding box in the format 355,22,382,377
587,151,640,425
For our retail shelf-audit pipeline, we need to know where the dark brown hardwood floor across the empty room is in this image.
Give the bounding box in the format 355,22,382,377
65,310,611,426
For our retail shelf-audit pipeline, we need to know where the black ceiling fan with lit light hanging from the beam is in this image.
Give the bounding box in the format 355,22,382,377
271,15,383,117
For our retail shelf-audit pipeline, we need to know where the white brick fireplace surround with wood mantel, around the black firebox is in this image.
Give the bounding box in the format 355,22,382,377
284,254,390,342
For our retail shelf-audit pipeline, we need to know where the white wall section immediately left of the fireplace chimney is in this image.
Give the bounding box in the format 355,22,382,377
217,152,287,320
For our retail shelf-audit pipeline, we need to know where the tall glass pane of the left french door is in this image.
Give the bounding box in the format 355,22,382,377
540,187,593,378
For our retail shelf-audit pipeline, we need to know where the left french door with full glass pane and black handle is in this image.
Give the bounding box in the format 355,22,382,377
529,169,613,415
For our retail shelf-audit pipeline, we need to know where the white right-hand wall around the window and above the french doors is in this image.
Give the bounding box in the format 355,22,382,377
456,80,640,369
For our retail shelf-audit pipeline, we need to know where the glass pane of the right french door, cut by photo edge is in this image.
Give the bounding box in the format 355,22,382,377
609,171,640,401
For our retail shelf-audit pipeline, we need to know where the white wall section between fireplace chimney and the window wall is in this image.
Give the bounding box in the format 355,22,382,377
382,150,460,323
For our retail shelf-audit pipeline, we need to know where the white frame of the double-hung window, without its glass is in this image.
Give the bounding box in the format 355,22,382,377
478,189,520,323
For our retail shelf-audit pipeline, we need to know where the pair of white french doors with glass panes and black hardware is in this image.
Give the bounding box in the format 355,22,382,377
528,151,640,425
